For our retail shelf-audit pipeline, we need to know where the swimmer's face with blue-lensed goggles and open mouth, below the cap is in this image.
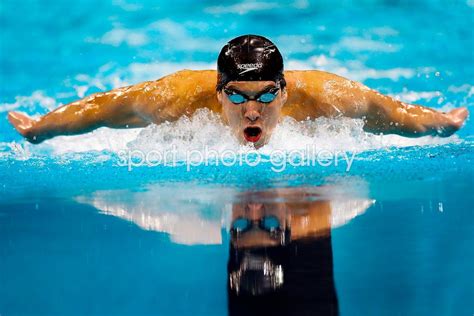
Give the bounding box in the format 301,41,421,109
217,81,287,148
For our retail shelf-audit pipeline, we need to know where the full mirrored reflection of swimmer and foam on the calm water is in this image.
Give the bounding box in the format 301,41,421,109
76,184,374,315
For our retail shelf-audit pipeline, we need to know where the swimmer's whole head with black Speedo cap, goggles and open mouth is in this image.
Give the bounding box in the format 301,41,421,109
216,35,287,147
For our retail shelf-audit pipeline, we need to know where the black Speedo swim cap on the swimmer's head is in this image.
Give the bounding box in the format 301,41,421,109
217,35,286,91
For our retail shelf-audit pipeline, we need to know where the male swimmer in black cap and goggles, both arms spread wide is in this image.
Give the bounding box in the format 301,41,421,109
8,35,468,148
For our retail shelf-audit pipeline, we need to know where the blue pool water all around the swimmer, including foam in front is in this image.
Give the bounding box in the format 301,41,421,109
0,0,474,316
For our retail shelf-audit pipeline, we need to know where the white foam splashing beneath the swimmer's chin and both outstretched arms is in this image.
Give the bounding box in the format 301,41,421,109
5,109,459,161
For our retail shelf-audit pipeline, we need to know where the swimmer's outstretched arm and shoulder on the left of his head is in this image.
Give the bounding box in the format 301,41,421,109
8,71,216,143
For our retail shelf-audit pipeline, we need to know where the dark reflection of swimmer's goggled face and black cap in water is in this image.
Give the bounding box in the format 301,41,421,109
228,193,354,315
